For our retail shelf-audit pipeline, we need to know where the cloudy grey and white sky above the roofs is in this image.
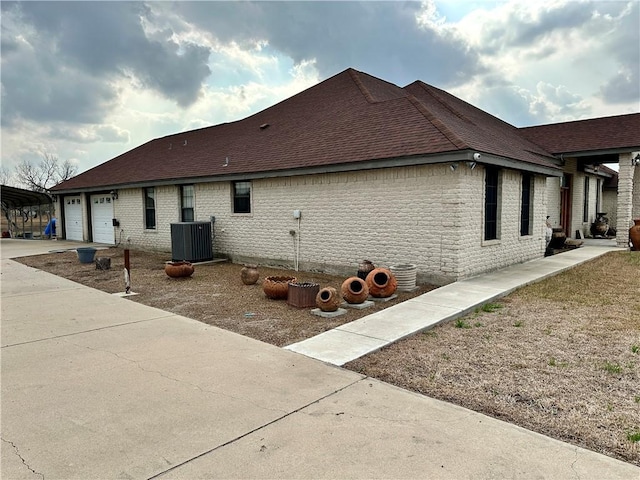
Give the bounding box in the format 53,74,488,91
0,0,640,178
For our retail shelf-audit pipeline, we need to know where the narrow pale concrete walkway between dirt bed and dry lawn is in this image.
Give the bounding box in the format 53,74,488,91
285,246,616,365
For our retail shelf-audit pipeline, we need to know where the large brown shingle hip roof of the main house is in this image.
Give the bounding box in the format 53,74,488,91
54,69,555,191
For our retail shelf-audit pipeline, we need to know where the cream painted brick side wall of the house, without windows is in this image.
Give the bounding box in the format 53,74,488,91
115,164,547,284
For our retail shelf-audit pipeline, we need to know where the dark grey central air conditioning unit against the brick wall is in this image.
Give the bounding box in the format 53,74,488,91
171,222,213,263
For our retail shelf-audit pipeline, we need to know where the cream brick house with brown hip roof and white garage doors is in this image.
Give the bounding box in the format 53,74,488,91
53,69,640,284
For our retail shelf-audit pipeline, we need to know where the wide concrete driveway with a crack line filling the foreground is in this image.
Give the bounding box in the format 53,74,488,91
0,240,640,479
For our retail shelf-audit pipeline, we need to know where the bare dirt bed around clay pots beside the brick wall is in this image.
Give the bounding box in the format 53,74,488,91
16,248,435,347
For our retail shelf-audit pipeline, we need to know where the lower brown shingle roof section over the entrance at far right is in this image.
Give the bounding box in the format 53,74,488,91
520,113,640,154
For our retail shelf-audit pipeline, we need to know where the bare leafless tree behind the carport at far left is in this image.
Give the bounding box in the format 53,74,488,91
16,152,77,192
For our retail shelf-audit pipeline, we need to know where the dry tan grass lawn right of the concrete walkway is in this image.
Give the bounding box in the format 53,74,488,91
346,252,640,465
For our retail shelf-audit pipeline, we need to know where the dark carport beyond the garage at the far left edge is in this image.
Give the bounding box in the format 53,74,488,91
0,185,55,238
